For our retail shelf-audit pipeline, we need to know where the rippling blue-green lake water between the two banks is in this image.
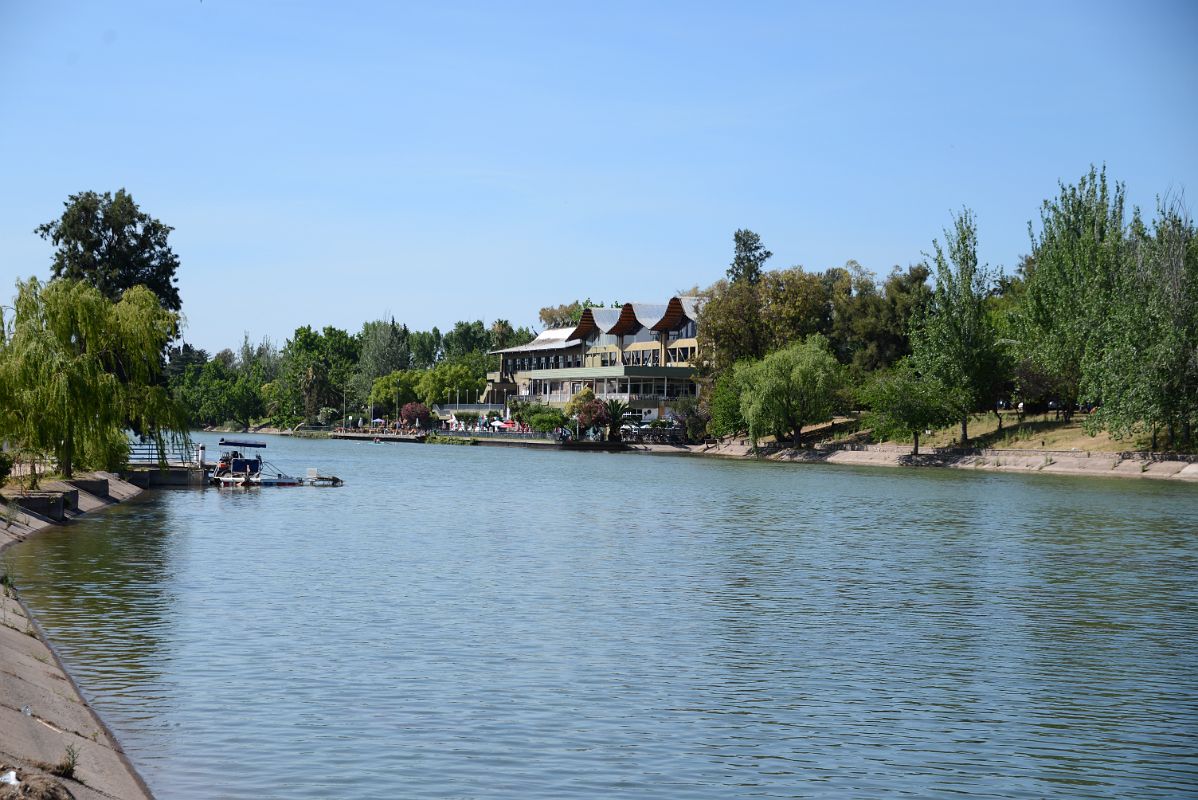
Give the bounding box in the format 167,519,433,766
6,440,1198,798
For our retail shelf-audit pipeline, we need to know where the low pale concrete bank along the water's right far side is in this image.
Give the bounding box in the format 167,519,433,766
639,440,1198,483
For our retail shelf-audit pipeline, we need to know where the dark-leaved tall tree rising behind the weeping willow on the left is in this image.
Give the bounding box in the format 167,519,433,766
35,189,182,311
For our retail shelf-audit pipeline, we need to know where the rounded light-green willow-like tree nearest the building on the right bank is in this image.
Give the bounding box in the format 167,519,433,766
736,334,845,447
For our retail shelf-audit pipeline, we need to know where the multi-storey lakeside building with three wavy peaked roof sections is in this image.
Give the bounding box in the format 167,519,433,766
485,297,698,419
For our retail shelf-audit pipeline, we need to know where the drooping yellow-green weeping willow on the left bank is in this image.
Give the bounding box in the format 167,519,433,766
0,278,187,477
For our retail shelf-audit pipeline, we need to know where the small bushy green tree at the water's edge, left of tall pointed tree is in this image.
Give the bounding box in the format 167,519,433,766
861,359,957,455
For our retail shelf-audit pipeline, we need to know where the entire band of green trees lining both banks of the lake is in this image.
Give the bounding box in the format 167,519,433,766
0,168,1198,483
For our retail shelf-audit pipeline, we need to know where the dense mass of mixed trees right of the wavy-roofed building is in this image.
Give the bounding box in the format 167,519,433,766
699,168,1198,451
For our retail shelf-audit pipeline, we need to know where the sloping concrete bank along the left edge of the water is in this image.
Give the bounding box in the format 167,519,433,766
0,473,152,800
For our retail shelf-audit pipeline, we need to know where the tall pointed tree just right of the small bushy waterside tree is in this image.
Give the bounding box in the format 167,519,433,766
912,208,1002,447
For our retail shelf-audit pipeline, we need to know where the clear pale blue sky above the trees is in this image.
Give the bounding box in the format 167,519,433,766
0,0,1198,352
